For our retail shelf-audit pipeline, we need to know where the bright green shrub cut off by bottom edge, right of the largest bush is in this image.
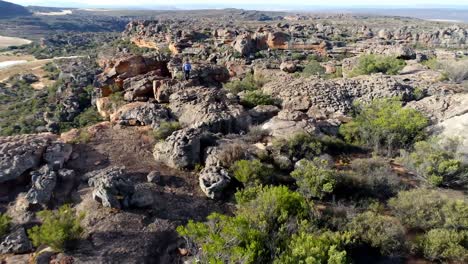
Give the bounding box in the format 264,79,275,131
274,231,349,264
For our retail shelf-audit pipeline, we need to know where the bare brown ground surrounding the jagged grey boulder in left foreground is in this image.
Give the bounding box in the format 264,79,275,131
63,122,232,263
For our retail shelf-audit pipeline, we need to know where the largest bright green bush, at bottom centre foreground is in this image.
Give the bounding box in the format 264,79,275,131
177,186,310,263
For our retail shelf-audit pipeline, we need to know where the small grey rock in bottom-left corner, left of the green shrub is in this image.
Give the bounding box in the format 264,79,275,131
0,227,33,254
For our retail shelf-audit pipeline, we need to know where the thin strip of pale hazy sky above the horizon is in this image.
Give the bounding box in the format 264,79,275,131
7,0,468,8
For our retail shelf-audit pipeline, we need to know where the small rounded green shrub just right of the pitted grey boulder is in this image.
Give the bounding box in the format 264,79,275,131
230,160,273,184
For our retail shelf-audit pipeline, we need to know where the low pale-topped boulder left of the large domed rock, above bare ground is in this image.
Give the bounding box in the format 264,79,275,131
111,102,170,128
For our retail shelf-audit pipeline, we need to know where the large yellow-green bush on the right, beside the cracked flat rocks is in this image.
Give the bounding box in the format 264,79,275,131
340,98,428,155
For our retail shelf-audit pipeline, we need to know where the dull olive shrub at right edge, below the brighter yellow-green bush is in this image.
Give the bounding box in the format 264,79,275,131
389,189,468,230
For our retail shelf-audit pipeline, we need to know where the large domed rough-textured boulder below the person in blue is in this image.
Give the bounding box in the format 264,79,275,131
169,87,250,134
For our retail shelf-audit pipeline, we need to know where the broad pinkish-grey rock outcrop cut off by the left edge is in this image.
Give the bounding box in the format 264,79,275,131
0,133,59,183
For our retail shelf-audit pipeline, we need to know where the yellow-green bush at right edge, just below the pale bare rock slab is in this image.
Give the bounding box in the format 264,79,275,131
399,140,468,186
